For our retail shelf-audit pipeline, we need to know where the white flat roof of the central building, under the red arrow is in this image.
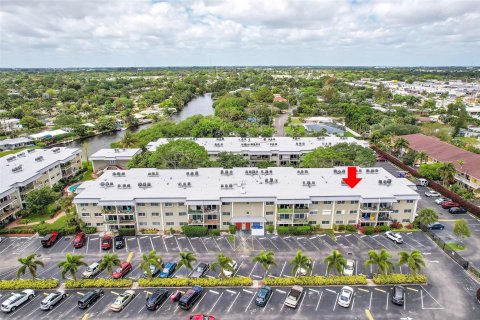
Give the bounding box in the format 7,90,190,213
74,167,419,205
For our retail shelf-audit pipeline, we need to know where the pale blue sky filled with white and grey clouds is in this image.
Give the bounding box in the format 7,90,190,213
0,0,480,68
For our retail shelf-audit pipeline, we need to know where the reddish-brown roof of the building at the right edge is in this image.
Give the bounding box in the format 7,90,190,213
402,133,480,178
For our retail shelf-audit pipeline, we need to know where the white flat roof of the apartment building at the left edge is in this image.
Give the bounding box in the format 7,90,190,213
0,147,80,196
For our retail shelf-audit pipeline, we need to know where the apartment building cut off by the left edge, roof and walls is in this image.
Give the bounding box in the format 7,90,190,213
0,148,82,226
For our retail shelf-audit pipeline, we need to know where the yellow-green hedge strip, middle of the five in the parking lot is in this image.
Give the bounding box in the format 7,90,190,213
138,277,253,287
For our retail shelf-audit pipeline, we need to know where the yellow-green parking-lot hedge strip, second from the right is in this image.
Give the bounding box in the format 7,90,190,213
265,275,367,286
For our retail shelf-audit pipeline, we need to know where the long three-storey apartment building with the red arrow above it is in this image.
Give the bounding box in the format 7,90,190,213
73,167,420,235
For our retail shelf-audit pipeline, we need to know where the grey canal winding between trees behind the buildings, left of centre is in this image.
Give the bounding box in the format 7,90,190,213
65,93,214,156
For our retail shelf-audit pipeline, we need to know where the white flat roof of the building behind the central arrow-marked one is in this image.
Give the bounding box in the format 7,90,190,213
147,136,368,154
